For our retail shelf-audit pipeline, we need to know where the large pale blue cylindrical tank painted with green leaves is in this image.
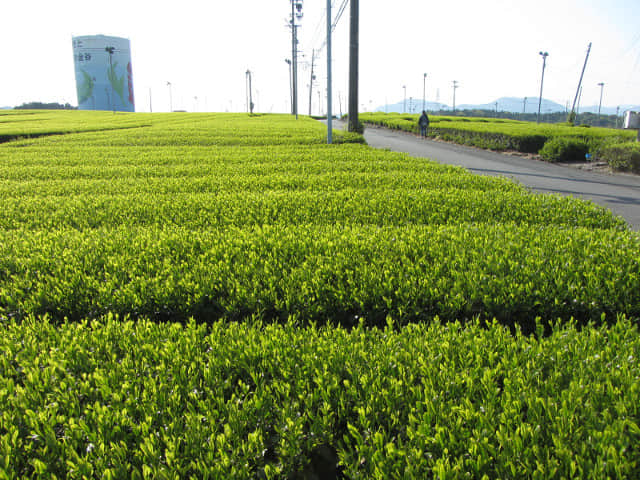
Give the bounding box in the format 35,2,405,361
72,35,135,112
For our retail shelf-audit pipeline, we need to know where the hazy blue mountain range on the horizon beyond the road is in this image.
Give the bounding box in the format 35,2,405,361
376,97,640,115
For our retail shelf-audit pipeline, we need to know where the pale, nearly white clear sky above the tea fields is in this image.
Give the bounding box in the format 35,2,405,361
0,0,640,113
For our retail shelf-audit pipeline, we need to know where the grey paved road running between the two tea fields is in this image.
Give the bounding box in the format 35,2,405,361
334,122,640,230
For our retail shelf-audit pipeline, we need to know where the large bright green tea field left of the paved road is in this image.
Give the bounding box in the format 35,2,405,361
0,112,640,479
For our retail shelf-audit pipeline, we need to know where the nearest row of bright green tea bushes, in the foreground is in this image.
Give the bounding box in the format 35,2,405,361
0,315,640,480
